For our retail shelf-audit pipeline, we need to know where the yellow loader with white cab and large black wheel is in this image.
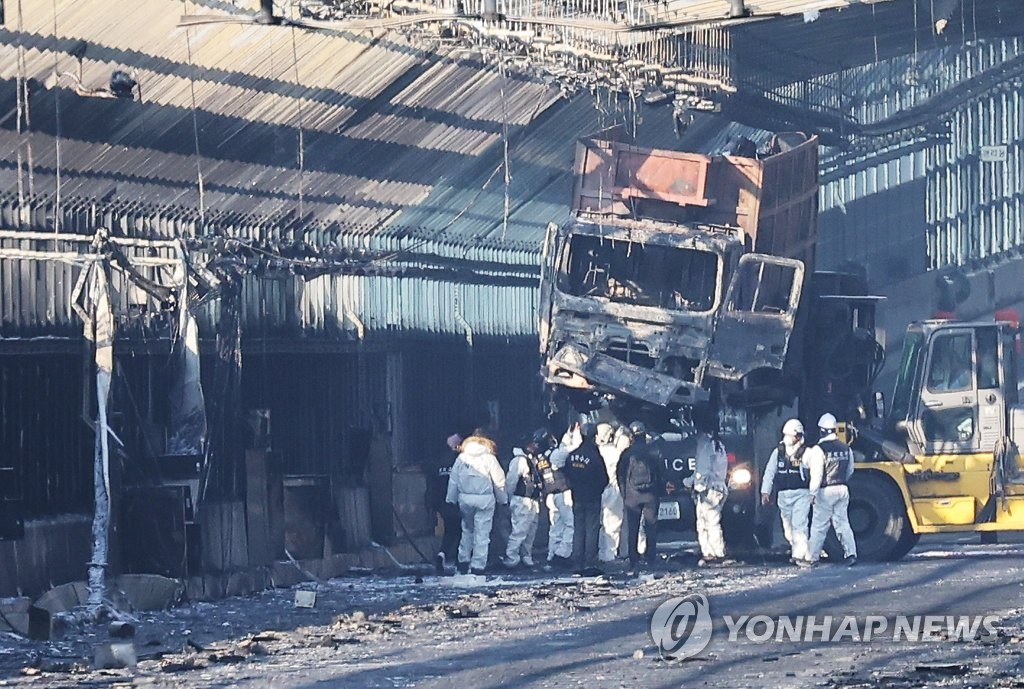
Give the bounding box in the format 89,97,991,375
849,320,1024,561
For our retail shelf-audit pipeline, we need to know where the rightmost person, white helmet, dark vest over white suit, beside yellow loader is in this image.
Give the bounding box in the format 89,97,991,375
798,414,857,566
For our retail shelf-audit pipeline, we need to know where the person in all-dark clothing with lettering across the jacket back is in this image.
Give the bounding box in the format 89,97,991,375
565,423,608,574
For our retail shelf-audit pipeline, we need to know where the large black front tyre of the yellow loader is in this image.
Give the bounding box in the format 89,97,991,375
849,472,913,562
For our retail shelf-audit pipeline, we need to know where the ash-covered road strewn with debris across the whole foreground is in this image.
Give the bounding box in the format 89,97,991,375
0,536,1024,689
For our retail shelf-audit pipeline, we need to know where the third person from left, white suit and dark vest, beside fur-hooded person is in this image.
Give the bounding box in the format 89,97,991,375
502,429,547,568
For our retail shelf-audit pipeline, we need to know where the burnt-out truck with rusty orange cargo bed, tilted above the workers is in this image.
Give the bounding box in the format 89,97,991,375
539,134,881,543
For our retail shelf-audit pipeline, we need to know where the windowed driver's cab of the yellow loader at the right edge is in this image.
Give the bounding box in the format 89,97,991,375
888,320,1018,456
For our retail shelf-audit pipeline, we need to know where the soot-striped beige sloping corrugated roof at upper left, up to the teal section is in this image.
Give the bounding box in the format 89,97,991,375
0,0,558,247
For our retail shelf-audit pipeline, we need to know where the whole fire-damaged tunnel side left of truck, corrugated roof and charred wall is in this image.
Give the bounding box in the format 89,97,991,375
0,0,589,596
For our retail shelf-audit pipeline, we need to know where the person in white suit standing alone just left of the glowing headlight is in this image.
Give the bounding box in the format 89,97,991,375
684,408,729,566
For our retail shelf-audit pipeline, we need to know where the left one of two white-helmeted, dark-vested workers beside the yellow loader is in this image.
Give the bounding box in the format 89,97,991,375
761,419,811,564
